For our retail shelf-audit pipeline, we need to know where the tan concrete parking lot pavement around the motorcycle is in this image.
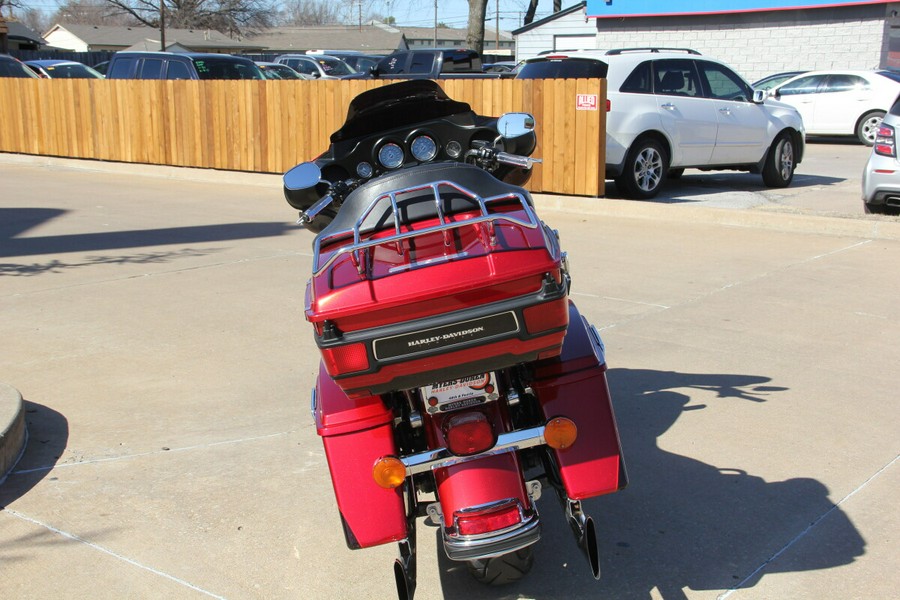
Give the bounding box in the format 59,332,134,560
0,143,900,600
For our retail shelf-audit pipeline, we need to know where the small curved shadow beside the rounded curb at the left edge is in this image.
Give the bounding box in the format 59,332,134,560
0,400,69,510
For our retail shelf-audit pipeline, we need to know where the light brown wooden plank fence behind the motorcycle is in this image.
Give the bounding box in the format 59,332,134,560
0,78,606,196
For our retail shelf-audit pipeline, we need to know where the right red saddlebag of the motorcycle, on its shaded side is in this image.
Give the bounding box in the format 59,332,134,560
532,303,627,500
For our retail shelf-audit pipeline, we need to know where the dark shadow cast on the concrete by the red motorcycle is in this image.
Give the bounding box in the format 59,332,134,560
434,369,865,600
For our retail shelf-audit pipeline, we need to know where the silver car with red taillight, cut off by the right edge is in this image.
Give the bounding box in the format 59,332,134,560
862,96,900,215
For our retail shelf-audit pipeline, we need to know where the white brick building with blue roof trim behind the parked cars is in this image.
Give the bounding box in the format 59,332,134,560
512,0,900,81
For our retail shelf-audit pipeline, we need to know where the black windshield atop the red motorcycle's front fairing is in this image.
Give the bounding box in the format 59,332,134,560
331,79,474,143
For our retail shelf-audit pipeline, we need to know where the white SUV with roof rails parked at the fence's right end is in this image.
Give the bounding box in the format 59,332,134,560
516,48,805,198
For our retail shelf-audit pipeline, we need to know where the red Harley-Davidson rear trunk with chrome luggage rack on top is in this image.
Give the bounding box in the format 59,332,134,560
306,163,569,397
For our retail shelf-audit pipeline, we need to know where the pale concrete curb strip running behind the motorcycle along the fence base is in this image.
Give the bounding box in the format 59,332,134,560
0,152,900,241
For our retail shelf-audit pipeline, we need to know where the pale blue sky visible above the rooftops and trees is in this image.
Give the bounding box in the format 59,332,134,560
10,0,578,31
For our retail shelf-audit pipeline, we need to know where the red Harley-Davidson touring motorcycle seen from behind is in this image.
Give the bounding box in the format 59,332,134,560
284,80,626,600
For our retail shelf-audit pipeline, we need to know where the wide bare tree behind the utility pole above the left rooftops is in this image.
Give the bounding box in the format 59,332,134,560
105,0,276,36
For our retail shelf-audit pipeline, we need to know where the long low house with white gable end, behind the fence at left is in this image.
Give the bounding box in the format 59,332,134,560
44,23,263,54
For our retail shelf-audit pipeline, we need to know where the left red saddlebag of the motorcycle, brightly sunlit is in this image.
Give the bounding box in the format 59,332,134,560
314,360,407,550
